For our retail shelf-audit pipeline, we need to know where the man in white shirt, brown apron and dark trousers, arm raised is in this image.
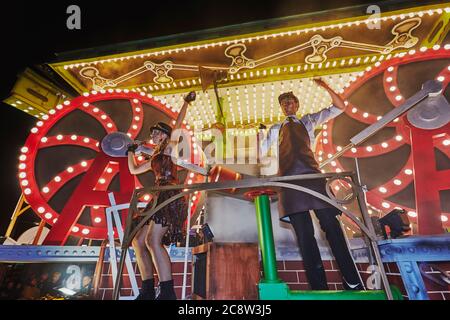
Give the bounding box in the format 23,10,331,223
261,79,364,290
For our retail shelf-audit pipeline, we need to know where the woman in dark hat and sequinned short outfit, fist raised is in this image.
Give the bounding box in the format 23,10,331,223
127,92,195,300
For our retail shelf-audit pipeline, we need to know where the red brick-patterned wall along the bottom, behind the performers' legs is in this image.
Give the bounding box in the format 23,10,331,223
97,260,450,300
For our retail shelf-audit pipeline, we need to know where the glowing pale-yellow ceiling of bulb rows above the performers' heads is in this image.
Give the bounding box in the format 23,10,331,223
151,73,358,128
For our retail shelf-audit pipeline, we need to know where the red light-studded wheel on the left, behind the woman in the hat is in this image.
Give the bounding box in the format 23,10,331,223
18,89,203,245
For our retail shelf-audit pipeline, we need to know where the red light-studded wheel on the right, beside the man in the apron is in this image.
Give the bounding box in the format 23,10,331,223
316,45,450,230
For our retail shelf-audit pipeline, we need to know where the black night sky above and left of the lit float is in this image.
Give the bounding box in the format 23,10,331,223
0,0,428,235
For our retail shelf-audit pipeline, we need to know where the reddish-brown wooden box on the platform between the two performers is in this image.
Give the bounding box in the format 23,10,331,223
192,242,260,300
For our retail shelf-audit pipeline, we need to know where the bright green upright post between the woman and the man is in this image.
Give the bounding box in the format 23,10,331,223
255,194,280,283
